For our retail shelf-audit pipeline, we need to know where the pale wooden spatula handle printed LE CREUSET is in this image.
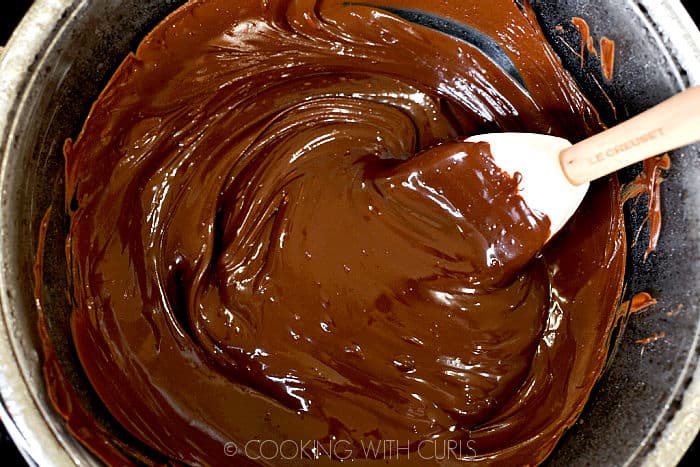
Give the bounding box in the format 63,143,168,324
560,86,700,185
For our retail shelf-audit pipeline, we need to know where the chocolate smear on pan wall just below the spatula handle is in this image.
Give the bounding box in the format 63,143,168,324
622,154,671,261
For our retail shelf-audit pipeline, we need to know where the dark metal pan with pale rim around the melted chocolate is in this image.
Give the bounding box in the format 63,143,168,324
0,0,700,466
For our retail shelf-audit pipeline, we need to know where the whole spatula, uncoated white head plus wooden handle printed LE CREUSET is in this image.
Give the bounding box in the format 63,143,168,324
467,86,700,249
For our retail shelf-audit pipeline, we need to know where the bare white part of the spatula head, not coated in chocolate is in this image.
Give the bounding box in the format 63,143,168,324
467,133,589,238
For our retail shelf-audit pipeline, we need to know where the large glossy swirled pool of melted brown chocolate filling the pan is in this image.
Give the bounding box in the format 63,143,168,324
47,0,625,465
